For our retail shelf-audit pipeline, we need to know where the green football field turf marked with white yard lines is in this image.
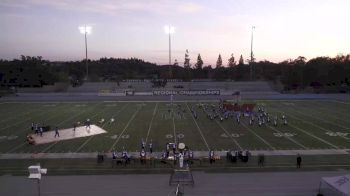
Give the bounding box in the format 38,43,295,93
0,100,350,153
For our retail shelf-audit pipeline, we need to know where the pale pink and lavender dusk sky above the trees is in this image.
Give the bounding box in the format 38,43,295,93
0,0,350,65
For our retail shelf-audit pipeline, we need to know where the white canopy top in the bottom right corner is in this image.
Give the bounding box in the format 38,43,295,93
322,174,350,196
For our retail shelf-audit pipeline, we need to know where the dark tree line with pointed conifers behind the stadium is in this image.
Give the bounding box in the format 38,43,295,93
0,50,350,90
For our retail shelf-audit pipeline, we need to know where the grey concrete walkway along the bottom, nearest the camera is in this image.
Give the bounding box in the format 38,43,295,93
0,171,349,196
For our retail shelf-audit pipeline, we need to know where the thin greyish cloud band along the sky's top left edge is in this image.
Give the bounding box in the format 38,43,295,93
0,0,204,15
